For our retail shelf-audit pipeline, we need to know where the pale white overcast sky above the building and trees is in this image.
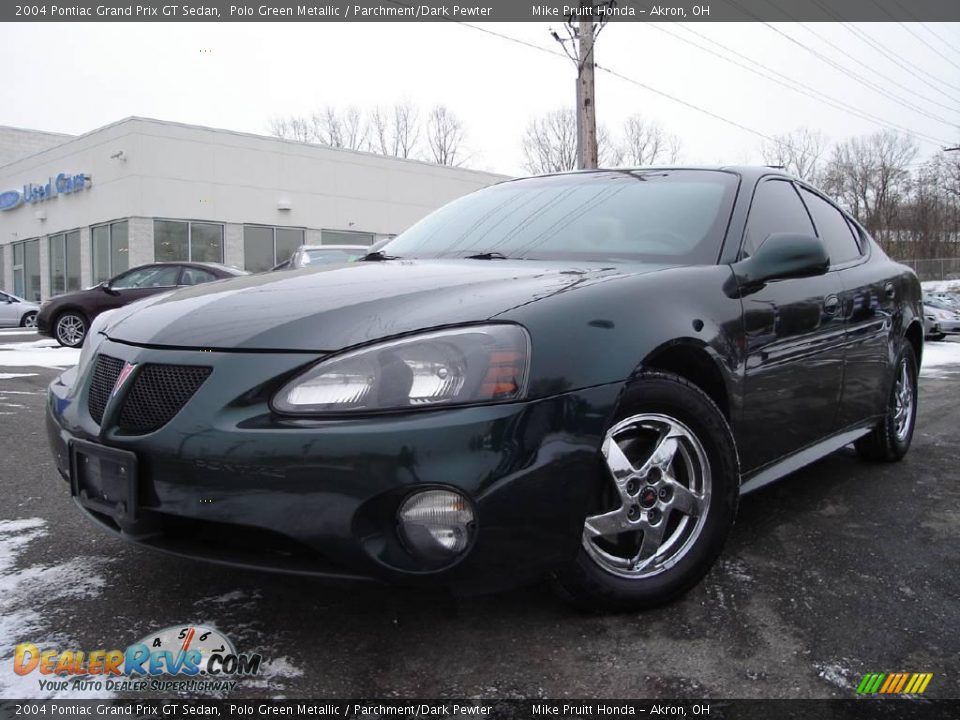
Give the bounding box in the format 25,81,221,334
0,22,960,174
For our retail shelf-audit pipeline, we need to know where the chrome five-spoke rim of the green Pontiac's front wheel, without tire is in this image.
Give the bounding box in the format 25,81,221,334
582,413,712,579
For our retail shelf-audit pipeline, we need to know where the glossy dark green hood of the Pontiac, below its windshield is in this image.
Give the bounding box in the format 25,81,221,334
106,260,666,352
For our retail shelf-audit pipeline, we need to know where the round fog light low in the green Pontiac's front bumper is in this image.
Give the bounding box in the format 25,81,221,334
398,490,474,562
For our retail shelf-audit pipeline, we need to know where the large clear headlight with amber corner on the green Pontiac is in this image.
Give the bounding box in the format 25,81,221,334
273,325,530,415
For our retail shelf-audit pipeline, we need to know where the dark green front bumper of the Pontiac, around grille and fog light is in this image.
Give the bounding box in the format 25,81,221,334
47,340,621,589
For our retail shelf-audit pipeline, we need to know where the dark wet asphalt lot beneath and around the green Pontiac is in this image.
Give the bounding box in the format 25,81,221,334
0,336,960,699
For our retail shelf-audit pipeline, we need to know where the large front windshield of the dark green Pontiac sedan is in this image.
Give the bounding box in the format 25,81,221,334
384,170,738,265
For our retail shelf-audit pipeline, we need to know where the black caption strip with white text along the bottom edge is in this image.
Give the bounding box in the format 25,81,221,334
0,697,960,720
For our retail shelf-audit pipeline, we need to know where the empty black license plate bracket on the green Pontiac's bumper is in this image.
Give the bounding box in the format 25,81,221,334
70,440,137,523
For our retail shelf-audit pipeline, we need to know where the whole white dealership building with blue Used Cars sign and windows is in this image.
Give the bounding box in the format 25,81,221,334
0,118,505,300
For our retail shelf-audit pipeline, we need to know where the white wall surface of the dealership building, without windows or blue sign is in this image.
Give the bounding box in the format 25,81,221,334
0,118,504,297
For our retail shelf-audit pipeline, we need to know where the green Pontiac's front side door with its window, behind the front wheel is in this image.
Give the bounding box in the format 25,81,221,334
739,178,844,471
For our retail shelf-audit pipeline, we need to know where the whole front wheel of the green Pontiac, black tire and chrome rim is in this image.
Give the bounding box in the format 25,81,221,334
556,372,740,611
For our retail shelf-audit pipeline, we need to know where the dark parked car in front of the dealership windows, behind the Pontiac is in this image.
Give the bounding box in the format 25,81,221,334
37,262,249,347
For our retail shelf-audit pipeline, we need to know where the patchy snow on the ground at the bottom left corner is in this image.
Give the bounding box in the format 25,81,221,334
0,518,110,698
